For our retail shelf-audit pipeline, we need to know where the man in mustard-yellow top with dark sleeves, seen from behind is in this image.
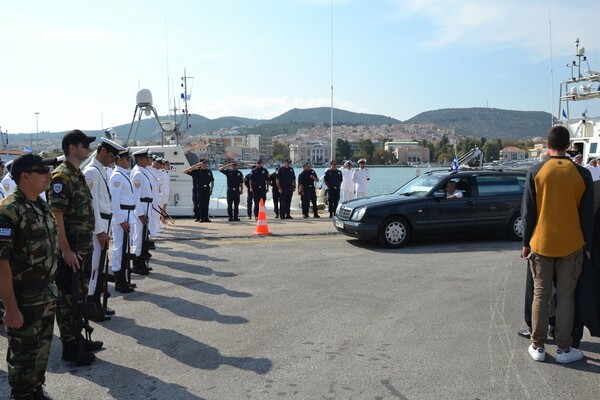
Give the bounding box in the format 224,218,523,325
521,126,594,363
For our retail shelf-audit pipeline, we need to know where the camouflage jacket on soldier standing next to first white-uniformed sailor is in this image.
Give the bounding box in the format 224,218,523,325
48,160,95,242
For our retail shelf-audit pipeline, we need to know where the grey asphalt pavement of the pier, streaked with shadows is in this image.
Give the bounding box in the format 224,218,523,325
0,214,600,400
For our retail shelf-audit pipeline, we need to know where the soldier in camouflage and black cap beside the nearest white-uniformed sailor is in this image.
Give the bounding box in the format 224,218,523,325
48,129,102,365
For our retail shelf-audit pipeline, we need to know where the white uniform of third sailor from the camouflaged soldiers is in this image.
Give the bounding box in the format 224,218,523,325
131,165,154,257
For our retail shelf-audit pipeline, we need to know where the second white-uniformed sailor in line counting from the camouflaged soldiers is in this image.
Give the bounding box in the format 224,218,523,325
109,150,135,293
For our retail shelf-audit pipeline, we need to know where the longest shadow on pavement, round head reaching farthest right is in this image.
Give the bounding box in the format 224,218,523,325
107,317,272,376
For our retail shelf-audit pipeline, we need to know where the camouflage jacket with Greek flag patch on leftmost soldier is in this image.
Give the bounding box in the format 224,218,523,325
0,188,58,306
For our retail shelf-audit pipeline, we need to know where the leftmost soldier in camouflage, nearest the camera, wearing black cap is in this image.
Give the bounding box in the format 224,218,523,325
0,154,58,400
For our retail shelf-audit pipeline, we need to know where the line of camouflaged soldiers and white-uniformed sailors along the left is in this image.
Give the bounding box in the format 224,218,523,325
0,130,170,399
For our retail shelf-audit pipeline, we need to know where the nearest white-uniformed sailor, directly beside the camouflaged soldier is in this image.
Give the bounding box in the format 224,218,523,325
83,138,125,322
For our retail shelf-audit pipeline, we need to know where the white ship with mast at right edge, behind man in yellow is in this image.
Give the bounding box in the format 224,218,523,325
558,39,600,163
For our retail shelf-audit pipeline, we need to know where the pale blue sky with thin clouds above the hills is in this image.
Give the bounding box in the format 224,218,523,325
0,0,600,133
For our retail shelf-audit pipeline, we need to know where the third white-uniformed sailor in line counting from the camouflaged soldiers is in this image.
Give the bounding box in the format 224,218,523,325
131,148,154,275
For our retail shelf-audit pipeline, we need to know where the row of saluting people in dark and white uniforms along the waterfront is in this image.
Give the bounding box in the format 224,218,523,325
183,158,370,222
